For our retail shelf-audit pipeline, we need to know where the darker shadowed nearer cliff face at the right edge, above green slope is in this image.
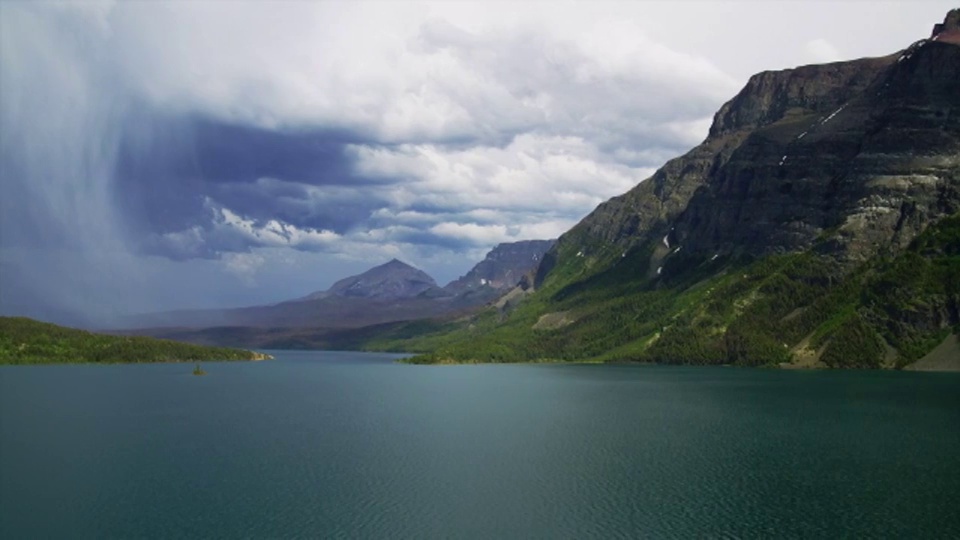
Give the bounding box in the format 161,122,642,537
674,37,960,263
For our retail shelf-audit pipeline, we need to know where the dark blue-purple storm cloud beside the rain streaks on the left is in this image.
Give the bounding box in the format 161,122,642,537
115,114,404,253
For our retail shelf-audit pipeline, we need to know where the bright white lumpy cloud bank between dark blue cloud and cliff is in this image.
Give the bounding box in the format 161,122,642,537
350,134,654,219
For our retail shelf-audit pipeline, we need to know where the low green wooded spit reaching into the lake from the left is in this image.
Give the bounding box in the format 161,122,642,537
0,317,272,368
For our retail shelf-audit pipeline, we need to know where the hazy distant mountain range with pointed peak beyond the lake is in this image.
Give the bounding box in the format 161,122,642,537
127,240,554,332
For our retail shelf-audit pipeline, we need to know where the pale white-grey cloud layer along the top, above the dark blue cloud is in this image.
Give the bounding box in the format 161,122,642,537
110,2,737,143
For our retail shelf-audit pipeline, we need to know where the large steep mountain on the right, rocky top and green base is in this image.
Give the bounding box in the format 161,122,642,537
378,10,960,368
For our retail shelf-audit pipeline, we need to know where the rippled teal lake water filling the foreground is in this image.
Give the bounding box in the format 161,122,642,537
0,352,960,538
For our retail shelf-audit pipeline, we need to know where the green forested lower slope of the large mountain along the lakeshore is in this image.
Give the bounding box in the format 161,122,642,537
376,215,960,368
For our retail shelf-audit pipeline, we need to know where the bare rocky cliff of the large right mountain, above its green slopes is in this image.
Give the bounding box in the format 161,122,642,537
539,18,960,282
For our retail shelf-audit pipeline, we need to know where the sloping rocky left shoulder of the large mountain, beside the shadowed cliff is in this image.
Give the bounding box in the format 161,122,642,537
538,55,896,281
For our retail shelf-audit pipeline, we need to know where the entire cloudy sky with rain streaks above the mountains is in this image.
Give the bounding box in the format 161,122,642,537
0,0,955,326
